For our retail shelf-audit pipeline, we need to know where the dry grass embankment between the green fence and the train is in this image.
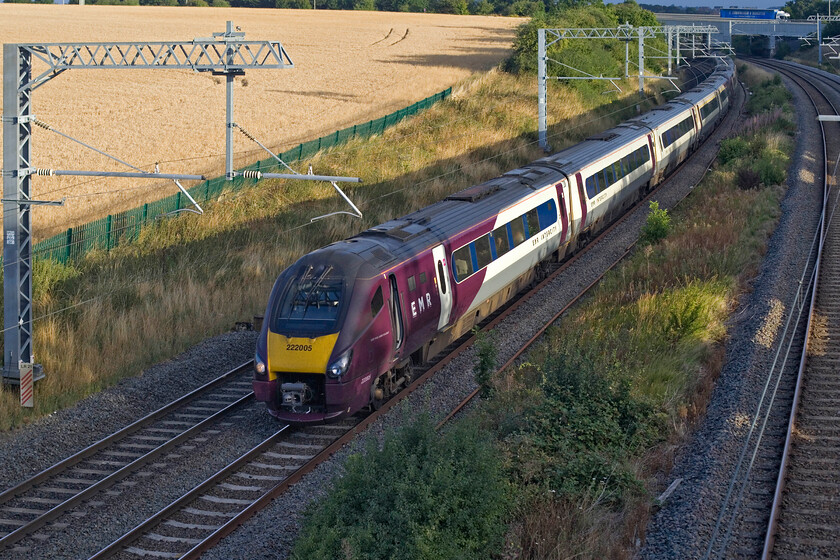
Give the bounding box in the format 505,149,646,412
0,68,668,429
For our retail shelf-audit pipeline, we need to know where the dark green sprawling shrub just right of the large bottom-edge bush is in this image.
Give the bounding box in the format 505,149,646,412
508,347,656,504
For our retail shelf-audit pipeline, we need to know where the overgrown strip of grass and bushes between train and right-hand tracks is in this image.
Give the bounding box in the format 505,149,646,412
296,63,794,559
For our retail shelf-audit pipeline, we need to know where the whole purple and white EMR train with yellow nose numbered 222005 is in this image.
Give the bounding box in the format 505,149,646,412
254,61,734,423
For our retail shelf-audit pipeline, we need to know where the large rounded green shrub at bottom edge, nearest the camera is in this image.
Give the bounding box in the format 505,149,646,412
292,417,509,560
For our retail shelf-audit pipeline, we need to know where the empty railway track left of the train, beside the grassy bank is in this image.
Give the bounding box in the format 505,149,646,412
0,362,254,551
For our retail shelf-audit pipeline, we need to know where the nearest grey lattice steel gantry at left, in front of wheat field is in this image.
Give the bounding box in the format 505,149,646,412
3,21,294,384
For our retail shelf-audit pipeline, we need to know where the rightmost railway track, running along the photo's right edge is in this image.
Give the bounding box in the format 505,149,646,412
762,61,840,559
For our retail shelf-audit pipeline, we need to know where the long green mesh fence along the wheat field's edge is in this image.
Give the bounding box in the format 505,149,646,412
32,88,452,263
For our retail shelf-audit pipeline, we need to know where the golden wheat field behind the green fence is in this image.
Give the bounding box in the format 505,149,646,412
0,4,523,239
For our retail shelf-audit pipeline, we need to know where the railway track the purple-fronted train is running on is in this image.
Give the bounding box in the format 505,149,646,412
83,59,740,560
